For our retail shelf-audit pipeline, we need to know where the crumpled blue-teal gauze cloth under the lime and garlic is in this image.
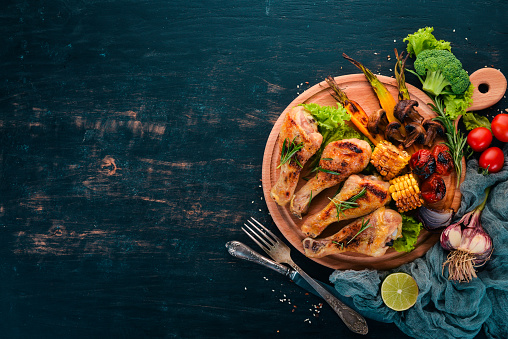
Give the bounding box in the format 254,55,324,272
330,145,508,339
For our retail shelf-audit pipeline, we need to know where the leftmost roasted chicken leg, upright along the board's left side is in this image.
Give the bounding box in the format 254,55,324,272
270,106,323,206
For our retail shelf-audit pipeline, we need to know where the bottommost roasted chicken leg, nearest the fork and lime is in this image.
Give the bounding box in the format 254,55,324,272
303,207,402,258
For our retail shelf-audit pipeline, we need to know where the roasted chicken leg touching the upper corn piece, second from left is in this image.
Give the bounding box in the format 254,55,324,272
290,139,372,218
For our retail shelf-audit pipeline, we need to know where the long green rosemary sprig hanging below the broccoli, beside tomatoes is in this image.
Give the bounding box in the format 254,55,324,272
429,97,467,187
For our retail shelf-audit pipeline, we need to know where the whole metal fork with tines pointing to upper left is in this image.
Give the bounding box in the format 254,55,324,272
242,218,369,334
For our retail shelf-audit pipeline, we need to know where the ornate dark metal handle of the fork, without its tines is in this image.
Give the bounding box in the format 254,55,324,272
290,262,369,334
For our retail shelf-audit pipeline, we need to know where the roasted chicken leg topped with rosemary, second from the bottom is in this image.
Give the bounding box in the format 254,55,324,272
302,174,391,238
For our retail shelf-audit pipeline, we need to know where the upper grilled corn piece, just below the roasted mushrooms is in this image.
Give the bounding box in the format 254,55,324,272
370,140,411,180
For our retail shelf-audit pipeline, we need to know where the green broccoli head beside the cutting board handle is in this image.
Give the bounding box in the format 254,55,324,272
414,49,471,96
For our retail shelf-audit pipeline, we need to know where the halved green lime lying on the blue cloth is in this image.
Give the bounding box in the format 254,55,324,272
381,272,418,311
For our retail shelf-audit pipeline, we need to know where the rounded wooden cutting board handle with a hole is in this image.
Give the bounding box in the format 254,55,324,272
467,67,506,112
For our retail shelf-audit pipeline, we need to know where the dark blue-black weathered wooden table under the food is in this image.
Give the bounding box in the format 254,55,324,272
0,0,508,338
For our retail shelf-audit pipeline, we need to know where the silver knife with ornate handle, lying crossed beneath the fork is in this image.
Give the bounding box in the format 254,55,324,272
226,241,358,311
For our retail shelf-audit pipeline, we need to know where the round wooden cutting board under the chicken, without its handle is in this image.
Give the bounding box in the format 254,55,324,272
262,73,465,270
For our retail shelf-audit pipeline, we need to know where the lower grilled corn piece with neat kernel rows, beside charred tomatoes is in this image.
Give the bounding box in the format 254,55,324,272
389,173,423,212
